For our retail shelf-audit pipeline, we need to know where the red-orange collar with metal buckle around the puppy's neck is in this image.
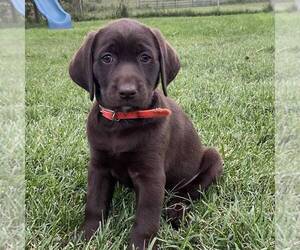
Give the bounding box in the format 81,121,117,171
99,105,172,121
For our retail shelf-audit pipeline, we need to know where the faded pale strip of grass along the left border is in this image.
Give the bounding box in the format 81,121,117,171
0,26,25,250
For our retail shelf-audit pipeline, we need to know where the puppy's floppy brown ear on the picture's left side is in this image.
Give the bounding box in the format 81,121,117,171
69,32,97,101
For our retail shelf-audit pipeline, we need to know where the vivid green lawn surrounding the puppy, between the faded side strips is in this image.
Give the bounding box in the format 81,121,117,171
26,13,275,250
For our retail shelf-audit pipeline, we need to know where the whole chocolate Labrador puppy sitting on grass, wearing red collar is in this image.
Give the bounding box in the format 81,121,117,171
69,19,223,250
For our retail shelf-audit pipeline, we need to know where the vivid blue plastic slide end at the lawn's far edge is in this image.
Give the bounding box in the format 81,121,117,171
33,0,72,29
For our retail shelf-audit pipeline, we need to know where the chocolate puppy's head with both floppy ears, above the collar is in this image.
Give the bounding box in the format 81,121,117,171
69,19,180,111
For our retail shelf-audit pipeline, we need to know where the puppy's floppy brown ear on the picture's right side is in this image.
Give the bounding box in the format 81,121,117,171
151,29,180,96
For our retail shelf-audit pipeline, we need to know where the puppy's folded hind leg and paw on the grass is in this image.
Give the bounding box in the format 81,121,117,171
166,148,223,229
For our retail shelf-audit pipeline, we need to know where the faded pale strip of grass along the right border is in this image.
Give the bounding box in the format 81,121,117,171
275,12,300,249
